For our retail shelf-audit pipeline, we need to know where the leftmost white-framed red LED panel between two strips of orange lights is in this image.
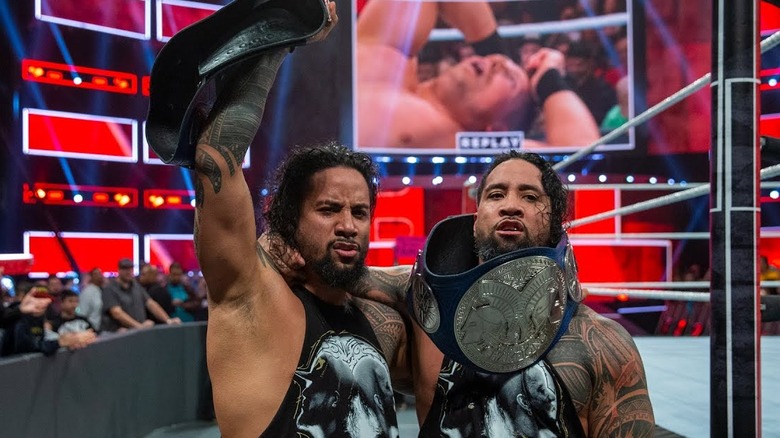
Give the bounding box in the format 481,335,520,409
22,108,138,163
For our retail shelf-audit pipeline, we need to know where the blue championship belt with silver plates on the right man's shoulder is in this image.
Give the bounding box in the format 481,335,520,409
407,214,583,373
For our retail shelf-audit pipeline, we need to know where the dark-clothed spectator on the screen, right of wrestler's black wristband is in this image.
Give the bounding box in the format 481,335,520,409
566,42,617,124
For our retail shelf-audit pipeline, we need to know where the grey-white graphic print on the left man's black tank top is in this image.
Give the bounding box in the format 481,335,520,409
293,332,399,438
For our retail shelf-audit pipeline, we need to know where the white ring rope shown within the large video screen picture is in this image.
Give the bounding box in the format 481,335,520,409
428,12,628,41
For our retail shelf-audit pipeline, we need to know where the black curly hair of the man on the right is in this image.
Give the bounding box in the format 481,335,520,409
477,150,569,247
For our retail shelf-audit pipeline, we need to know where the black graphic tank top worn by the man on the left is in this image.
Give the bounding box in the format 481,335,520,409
260,288,398,438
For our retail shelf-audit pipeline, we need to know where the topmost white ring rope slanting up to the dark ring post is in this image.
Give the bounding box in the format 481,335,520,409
553,31,780,171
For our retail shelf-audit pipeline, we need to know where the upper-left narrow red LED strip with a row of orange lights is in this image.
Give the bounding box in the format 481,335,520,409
22,59,138,94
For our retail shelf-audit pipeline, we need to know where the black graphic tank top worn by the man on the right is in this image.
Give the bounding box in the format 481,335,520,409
420,358,585,438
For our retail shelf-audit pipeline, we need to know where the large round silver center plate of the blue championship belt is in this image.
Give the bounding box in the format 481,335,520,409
454,256,567,373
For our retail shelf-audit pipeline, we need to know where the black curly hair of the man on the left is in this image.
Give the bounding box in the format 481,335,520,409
263,142,379,250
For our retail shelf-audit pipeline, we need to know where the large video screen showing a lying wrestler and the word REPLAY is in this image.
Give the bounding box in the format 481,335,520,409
353,0,637,155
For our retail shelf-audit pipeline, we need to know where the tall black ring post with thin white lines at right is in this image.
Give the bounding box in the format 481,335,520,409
710,0,761,437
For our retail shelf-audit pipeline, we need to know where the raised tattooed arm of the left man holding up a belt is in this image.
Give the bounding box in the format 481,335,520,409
194,49,287,306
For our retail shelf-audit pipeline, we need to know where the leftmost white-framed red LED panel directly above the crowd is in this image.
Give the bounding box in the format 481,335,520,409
24,231,138,276
